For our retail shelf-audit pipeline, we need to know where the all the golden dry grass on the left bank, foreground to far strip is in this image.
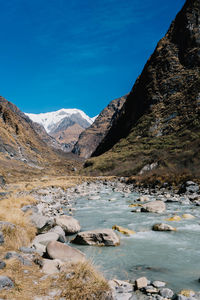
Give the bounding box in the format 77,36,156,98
0,175,112,300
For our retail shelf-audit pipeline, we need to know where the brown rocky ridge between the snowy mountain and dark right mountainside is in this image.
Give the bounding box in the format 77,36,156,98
72,96,127,158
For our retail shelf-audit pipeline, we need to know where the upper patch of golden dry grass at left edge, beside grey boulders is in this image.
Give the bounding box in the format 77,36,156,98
0,196,36,250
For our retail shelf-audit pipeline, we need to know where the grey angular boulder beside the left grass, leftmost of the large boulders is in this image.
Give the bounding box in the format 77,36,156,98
31,213,54,233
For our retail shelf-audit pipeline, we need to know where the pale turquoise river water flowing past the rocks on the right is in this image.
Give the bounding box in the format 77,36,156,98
67,188,200,291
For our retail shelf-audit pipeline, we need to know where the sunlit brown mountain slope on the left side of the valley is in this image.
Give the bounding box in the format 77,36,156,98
0,97,82,182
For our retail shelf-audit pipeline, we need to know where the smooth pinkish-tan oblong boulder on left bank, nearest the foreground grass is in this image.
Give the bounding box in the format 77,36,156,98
46,242,85,263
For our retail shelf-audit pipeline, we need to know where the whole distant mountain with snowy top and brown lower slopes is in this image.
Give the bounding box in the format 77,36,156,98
26,108,96,152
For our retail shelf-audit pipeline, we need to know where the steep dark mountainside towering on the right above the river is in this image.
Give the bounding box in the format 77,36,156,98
85,0,200,180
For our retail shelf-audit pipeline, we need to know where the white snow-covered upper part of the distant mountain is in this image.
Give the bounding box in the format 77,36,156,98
26,108,95,134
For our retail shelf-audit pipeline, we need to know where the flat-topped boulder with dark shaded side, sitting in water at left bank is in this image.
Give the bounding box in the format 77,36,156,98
72,229,120,246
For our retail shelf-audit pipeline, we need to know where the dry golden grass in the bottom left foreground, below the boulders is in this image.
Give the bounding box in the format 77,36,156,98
0,259,109,300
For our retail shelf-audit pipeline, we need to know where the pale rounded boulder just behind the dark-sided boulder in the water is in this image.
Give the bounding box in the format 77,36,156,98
56,215,81,234
